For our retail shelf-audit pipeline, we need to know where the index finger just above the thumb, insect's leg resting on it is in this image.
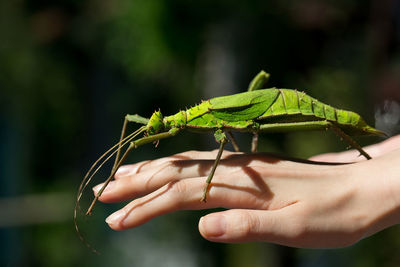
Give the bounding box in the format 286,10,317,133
106,176,271,230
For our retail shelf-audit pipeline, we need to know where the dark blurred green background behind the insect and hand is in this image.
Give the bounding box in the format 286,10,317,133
0,0,400,267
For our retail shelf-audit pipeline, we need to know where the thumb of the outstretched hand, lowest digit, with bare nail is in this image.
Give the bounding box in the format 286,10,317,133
199,207,302,244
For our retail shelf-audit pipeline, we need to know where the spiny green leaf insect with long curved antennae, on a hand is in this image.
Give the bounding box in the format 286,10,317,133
74,71,385,253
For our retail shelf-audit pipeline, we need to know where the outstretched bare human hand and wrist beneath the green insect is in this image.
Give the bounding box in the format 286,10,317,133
94,135,400,248
